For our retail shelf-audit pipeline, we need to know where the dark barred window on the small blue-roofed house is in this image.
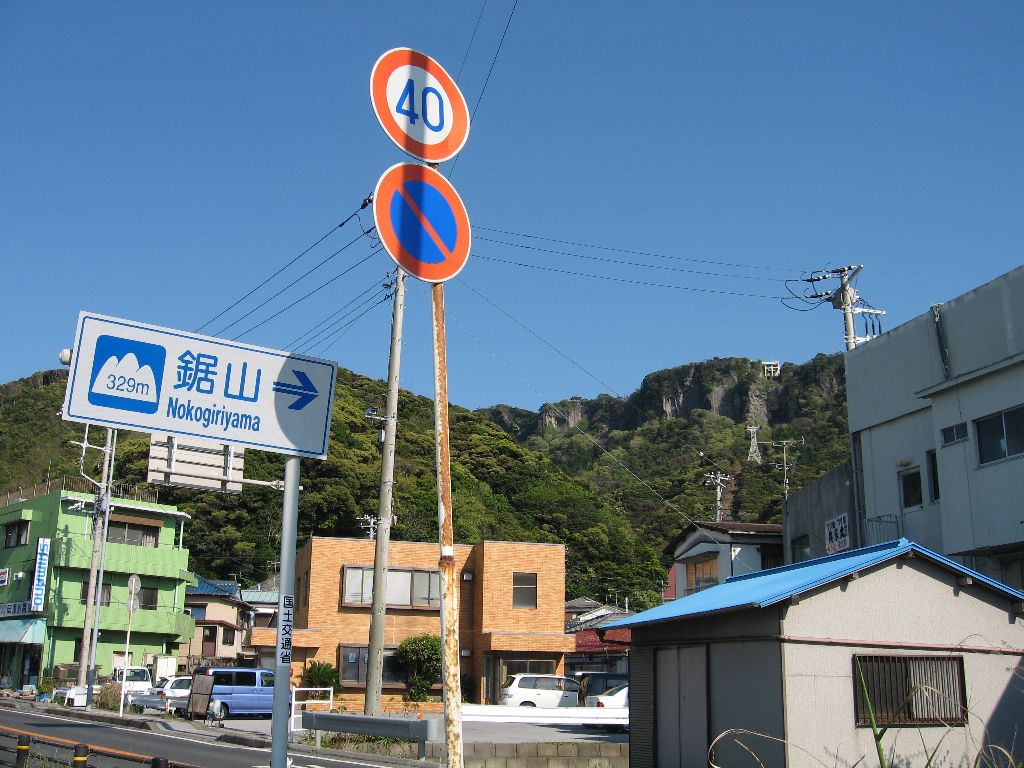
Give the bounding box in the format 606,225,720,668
853,655,967,727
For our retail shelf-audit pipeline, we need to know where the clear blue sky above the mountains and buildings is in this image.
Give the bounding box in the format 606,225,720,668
0,0,1024,409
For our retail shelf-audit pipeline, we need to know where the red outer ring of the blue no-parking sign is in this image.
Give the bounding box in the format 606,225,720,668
374,163,472,283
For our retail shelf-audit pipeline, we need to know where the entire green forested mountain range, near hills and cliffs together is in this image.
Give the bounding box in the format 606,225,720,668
0,355,847,607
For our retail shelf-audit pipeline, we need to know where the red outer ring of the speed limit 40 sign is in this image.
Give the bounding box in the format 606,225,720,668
370,48,469,163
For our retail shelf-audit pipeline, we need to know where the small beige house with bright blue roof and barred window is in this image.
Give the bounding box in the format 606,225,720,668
607,539,1024,768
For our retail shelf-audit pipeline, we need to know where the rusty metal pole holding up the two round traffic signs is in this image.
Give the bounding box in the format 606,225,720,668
430,283,463,768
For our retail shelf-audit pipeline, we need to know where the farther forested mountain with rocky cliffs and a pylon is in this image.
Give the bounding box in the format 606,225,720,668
479,354,849,561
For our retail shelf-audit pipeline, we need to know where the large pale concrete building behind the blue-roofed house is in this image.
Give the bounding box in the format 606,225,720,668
846,267,1024,589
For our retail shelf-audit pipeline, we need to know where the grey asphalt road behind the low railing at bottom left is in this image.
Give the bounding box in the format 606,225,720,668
0,709,385,768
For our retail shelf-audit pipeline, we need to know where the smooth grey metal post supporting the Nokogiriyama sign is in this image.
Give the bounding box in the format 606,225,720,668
270,456,300,768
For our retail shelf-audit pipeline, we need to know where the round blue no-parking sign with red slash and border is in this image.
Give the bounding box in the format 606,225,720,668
374,163,471,283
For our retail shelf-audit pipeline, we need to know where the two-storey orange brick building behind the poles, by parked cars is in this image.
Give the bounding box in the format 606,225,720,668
252,537,574,705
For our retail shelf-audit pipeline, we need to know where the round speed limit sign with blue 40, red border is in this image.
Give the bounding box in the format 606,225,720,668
370,48,469,163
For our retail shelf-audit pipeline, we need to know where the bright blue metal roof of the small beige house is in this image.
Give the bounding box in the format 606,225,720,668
603,539,1024,629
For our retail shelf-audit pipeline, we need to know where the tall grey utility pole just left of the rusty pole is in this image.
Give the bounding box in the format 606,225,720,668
362,268,406,717
